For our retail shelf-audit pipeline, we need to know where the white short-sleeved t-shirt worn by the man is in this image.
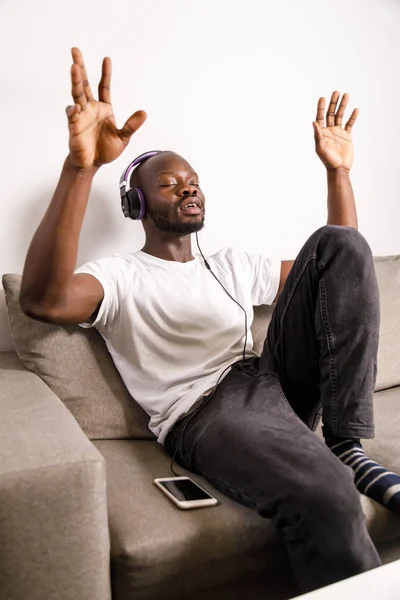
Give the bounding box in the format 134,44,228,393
76,249,280,443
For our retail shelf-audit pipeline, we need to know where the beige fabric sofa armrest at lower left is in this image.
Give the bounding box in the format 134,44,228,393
0,352,111,600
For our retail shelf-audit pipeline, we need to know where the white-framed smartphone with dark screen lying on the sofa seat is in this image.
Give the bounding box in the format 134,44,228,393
154,477,218,510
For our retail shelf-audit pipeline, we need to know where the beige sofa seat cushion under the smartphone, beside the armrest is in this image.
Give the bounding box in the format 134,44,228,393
95,440,298,600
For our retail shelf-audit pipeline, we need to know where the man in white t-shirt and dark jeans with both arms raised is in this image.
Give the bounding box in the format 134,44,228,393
20,49,400,591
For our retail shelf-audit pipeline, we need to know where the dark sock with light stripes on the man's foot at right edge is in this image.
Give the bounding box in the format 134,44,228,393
326,439,400,514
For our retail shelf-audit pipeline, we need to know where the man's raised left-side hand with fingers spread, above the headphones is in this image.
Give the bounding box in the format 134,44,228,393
66,48,147,169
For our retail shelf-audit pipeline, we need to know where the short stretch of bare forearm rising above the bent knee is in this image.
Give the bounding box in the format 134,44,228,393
327,168,358,229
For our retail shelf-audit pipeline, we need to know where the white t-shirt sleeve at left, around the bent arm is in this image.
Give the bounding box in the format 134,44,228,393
75,256,128,333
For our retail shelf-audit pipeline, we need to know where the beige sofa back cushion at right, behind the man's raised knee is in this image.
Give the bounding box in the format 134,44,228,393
252,256,400,391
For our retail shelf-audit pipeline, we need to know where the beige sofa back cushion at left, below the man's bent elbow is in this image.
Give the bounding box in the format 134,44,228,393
3,275,154,439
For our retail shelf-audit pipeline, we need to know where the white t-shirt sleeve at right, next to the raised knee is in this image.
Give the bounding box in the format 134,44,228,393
234,252,281,306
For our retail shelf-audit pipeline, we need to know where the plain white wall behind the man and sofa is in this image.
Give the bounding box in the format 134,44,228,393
0,0,400,350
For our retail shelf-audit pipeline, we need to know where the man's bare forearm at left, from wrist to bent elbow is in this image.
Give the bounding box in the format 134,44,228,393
21,158,96,307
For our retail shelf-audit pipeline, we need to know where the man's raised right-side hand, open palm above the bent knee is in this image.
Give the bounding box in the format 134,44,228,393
313,92,359,170
